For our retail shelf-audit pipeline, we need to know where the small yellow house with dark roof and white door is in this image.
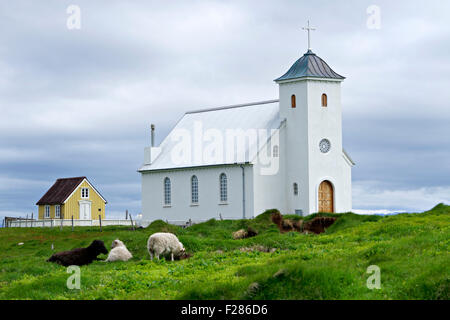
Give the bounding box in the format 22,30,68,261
36,177,106,220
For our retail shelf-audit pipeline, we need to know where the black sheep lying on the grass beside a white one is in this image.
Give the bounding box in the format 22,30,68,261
47,240,108,267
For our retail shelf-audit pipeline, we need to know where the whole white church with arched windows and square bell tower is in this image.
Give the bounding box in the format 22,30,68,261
138,30,354,224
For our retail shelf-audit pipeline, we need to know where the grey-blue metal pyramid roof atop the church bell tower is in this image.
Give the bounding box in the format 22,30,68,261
275,50,345,81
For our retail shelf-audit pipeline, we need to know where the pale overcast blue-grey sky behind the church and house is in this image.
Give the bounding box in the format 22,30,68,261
0,0,450,218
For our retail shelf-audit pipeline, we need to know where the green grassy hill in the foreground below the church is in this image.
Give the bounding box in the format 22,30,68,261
0,204,450,299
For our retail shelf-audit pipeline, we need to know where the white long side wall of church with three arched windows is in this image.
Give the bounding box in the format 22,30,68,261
142,165,254,223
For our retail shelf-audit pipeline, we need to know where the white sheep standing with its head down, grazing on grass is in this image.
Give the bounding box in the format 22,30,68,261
147,232,185,261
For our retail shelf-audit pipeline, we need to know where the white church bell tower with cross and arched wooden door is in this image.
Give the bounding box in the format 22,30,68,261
275,22,354,215
